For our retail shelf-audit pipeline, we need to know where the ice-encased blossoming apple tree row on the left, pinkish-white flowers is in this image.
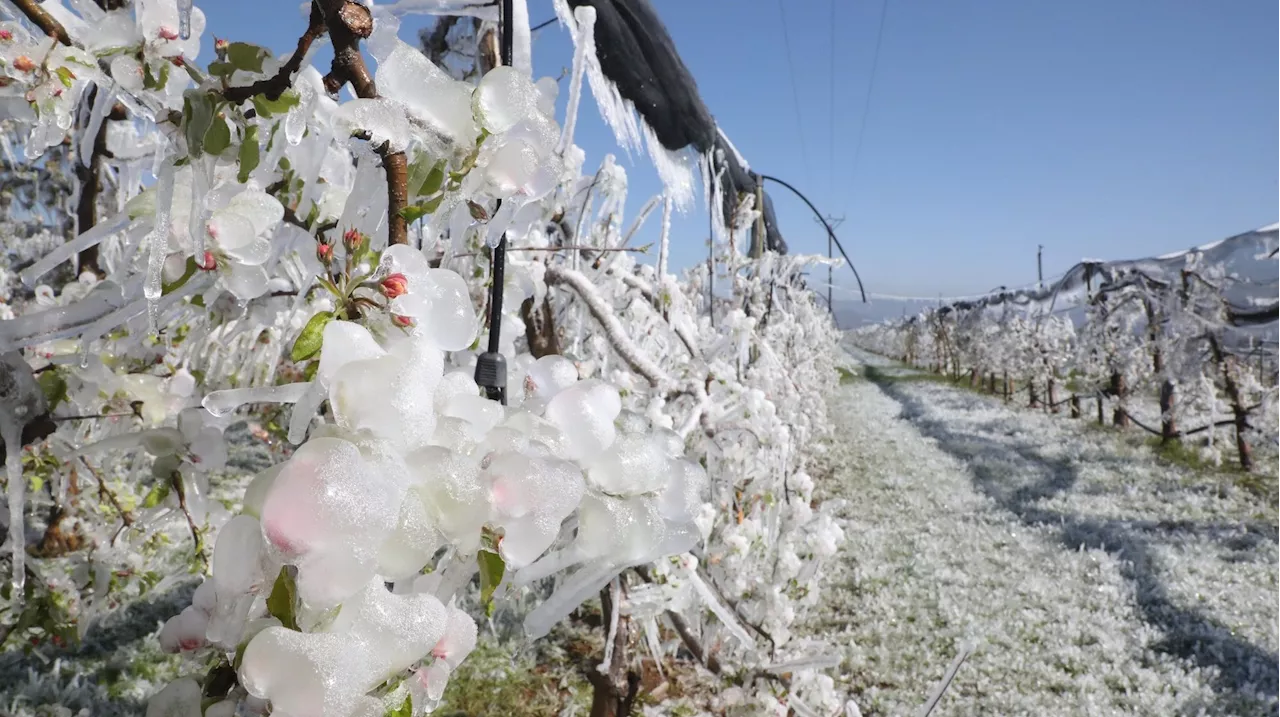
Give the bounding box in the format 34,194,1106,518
0,0,860,716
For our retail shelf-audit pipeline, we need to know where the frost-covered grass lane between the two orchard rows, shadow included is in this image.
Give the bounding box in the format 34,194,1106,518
810,355,1280,717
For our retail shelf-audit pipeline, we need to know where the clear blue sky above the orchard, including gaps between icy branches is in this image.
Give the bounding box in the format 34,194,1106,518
197,0,1280,296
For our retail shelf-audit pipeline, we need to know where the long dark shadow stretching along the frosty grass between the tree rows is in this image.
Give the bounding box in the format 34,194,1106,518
867,366,1280,714
